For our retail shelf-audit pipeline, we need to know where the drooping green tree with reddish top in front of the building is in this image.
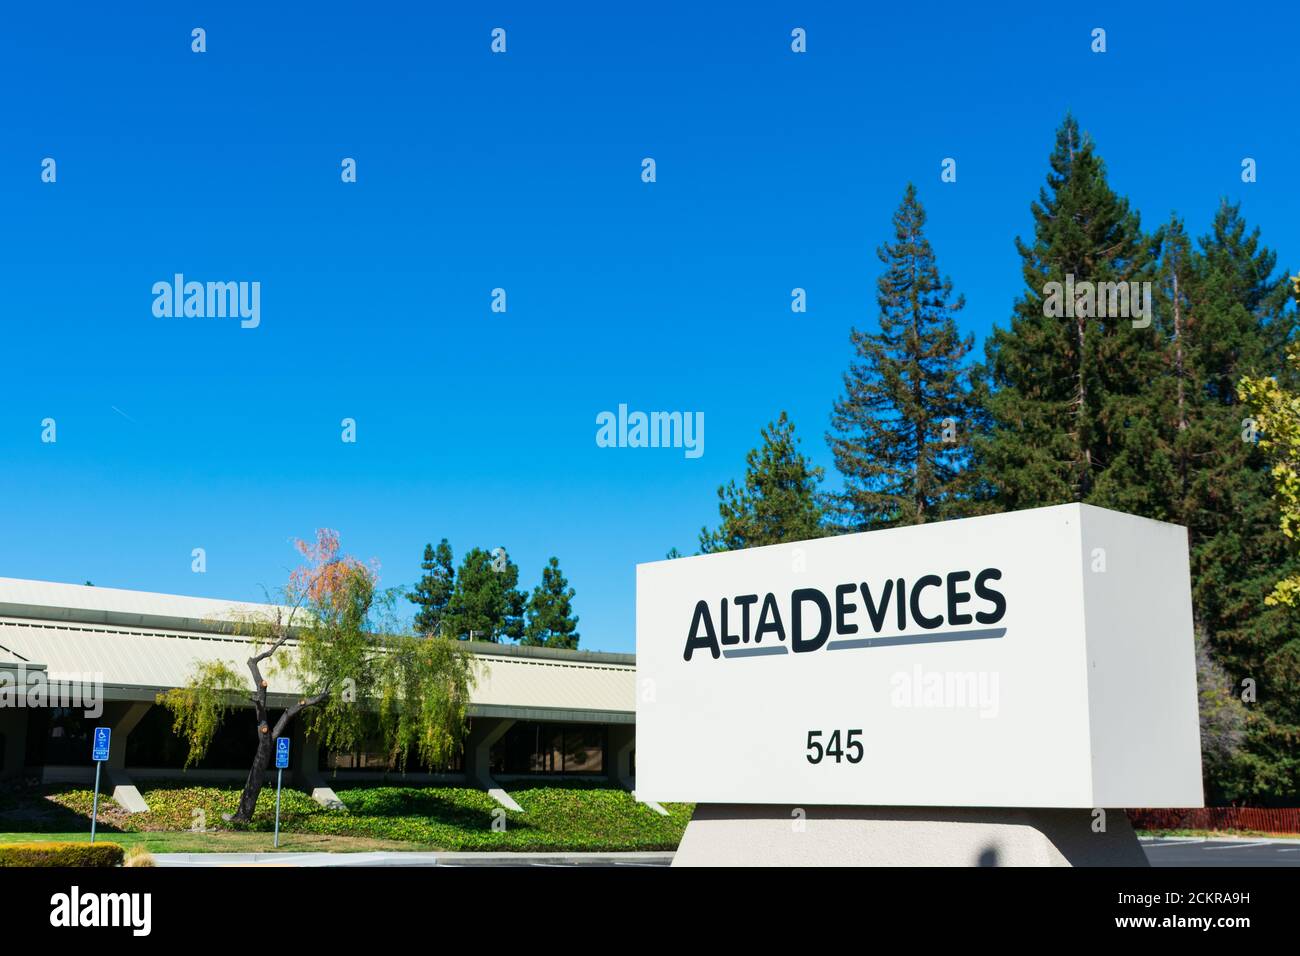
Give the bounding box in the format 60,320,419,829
157,529,473,823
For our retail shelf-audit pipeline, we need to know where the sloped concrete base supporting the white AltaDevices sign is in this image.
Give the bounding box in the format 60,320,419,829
672,804,1148,866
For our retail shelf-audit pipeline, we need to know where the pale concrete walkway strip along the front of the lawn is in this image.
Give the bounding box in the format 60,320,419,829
153,851,672,866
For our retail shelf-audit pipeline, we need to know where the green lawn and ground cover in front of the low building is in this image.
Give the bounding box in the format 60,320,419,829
0,782,692,853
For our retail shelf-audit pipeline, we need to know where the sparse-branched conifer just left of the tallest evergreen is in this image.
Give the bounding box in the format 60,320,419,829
827,183,976,531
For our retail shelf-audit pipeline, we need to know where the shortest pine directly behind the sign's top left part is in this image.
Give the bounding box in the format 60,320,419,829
702,411,826,557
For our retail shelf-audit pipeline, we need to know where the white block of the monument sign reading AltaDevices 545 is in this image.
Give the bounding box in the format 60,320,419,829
636,505,1203,808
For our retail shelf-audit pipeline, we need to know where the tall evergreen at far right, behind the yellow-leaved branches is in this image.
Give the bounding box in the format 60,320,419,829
1166,203,1300,801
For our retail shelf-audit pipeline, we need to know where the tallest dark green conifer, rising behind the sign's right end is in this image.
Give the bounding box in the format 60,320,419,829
975,116,1174,518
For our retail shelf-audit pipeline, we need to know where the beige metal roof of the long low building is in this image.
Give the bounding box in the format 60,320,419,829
0,578,636,722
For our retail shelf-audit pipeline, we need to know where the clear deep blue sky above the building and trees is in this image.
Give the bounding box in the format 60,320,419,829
0,3,1300,650
